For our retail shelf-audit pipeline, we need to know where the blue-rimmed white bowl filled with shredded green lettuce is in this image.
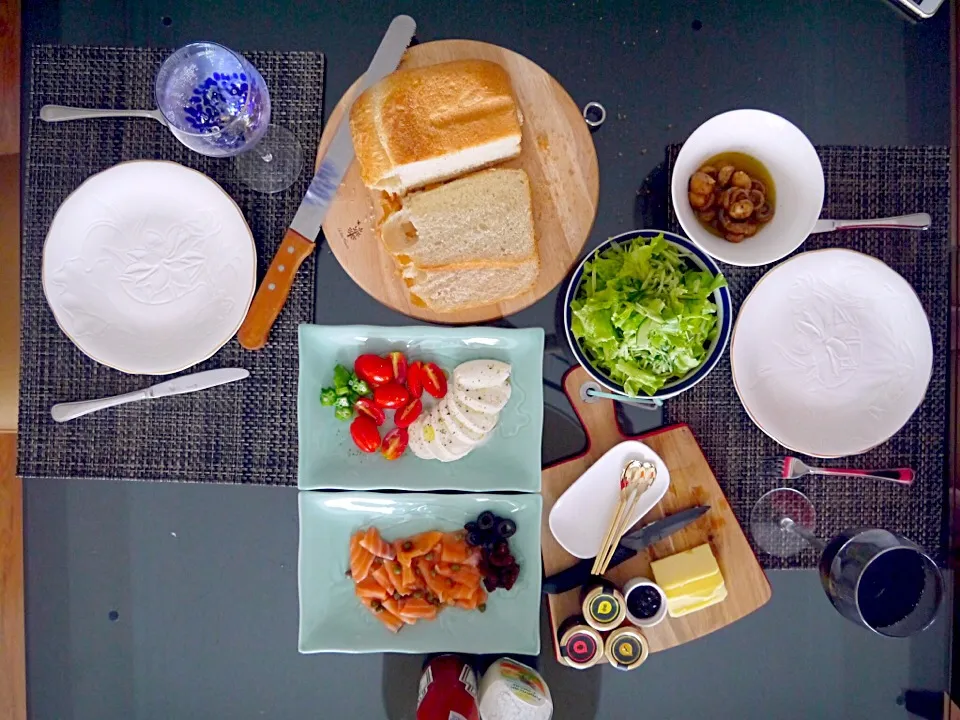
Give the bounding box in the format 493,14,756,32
564,230,733,400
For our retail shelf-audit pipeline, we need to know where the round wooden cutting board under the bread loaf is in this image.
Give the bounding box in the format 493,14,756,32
317,40,600,324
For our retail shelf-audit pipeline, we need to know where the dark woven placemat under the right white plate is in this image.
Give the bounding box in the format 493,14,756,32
664,146,950,567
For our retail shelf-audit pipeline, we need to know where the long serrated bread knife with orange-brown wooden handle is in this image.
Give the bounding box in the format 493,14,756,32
237,15,417,350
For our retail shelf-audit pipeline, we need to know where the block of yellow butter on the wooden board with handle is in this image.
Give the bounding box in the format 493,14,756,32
650,544,727,617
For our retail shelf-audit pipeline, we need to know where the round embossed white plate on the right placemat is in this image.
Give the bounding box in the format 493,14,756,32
730,249,933,457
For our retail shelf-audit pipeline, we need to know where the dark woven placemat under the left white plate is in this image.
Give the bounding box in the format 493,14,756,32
18,45,324,485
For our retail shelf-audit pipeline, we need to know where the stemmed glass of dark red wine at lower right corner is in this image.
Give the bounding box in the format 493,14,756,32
750,488,943,638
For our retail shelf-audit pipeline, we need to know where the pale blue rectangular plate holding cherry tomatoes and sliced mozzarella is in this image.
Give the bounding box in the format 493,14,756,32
297,325,543,492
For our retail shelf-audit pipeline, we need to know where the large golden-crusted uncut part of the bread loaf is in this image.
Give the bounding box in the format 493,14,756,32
350,60,522,195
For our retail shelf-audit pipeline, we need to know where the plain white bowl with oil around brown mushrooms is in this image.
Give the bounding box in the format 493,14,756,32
671,105,824,266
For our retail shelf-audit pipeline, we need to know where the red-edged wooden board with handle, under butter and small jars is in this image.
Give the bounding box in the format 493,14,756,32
540,367,771,662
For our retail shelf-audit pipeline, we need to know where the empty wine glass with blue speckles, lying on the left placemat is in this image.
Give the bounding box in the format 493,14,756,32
156,42,303,193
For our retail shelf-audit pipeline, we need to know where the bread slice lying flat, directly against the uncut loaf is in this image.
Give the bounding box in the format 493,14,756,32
380,168,537,268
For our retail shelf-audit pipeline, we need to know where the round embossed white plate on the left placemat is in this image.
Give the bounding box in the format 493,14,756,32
43,160,257,375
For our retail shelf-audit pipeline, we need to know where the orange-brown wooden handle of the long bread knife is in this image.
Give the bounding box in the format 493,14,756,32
237,228,317,350
